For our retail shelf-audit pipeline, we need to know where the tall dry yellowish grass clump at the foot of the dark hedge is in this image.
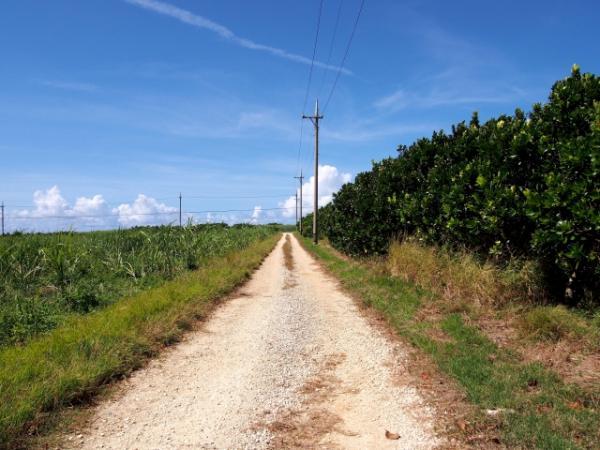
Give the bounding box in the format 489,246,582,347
387,239,600,351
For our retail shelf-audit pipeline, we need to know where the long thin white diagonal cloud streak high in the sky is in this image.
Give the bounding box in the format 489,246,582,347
125,0,352,75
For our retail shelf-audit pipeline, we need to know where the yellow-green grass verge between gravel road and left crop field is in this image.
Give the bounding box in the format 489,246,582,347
0,234,280,448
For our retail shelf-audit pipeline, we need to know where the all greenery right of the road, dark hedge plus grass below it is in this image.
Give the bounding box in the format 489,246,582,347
303,65,600,449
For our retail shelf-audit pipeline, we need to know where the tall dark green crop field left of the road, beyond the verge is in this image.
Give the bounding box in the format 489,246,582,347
0,224,275,347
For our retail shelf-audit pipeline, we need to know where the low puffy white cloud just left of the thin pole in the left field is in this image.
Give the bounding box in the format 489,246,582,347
112,194,178,226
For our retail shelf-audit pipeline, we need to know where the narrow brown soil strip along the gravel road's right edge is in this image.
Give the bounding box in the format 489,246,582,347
296,236,496,450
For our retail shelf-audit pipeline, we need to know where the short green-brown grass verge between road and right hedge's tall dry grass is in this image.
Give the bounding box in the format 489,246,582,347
299,238,600,449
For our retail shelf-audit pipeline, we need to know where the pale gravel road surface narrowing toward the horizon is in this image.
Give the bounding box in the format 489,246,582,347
63,235,441,449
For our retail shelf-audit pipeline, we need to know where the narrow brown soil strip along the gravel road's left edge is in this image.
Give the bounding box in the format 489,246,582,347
18,232,283,450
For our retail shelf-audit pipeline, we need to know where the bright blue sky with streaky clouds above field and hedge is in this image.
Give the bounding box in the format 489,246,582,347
0,0,600,229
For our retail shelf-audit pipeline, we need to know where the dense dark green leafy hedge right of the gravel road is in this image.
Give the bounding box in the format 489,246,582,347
307,66,600,302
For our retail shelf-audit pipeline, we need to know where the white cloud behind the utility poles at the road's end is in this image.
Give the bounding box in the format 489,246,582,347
279,165,352,218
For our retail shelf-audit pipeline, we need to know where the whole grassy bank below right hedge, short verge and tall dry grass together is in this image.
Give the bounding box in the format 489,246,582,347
303,234,600,449
